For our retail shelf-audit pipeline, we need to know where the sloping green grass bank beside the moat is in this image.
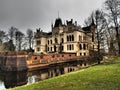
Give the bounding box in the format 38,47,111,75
12,58,120,90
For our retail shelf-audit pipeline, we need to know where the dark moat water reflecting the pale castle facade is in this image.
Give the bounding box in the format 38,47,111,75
0,63,80,90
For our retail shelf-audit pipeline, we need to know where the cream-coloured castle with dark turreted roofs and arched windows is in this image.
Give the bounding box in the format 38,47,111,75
34,18,97,56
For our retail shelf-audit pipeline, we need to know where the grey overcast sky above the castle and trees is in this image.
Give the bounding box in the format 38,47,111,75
0,0,105,32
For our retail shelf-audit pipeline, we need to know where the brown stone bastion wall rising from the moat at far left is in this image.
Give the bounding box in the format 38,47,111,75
0,53,28,71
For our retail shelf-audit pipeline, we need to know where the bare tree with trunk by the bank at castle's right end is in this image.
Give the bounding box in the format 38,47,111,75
85,9,106,64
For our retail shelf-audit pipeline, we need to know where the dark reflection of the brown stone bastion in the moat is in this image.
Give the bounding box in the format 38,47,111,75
0,71,27,88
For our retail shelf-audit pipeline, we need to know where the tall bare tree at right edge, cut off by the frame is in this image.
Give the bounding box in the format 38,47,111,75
104,0,120,55
